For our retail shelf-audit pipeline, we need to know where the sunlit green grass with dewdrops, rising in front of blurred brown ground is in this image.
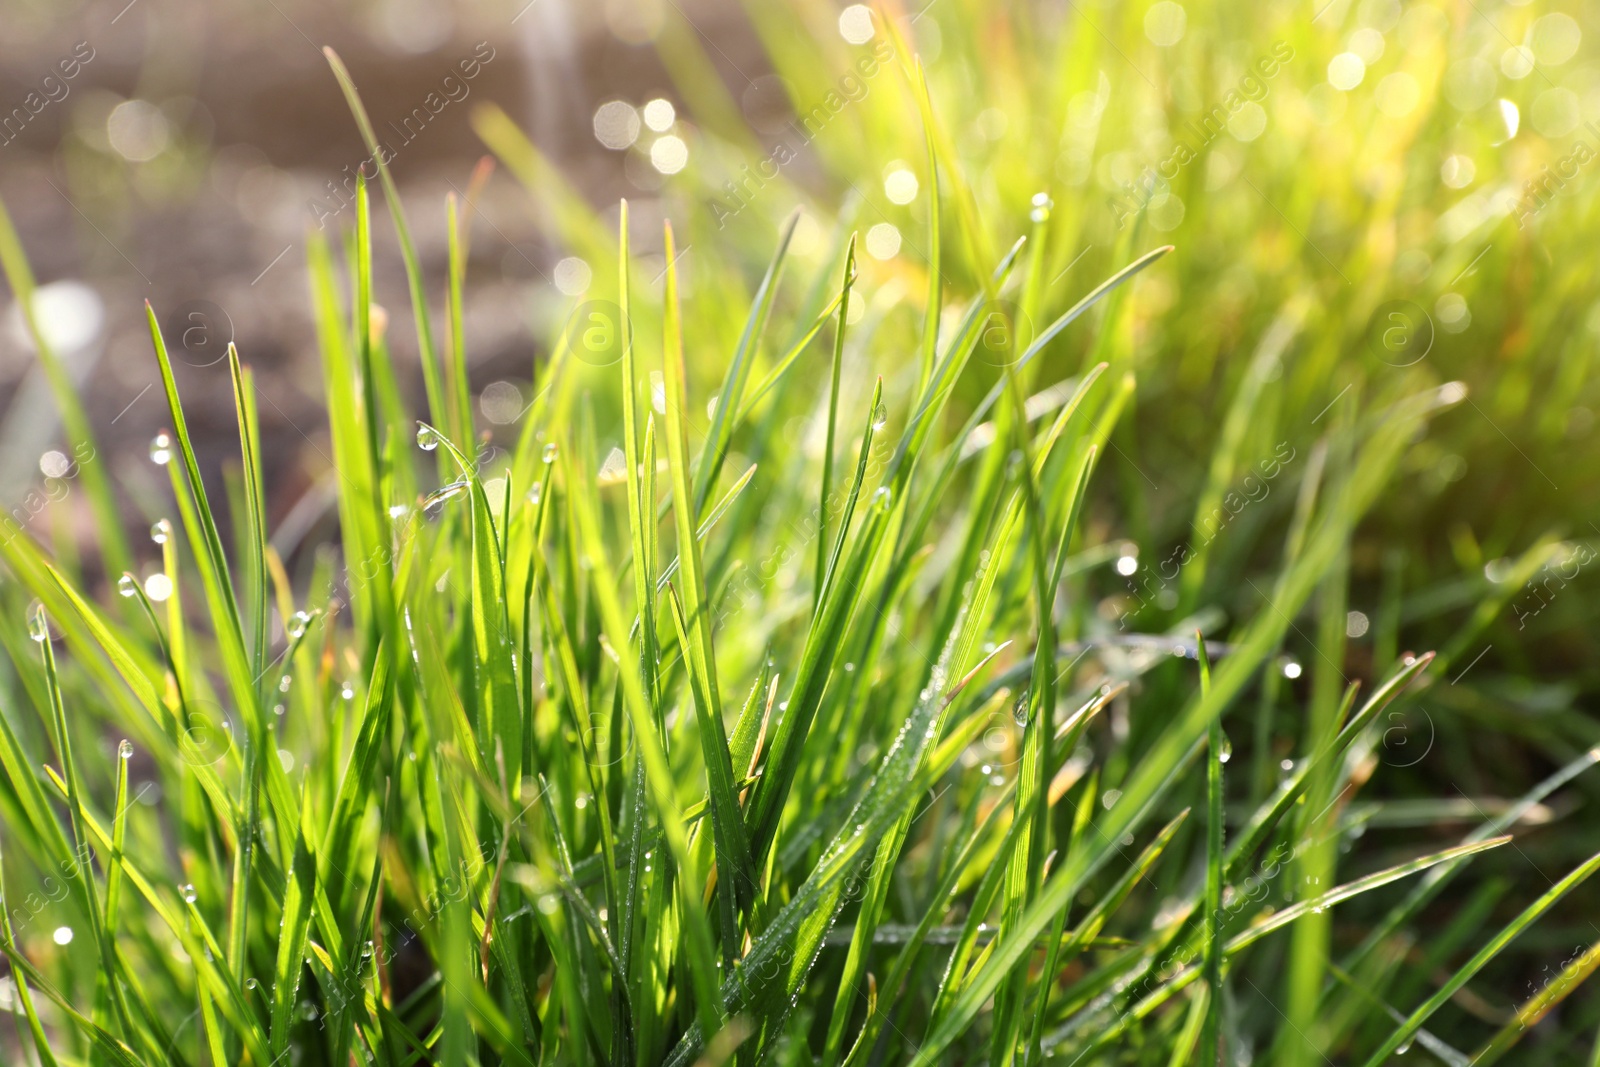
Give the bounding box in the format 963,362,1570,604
0,0,1600,1067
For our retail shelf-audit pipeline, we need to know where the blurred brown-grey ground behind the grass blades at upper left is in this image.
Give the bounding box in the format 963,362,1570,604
0,0,748,547
